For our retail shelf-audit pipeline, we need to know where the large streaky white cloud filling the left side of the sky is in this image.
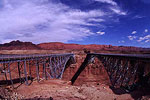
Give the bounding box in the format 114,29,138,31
0,0,126,43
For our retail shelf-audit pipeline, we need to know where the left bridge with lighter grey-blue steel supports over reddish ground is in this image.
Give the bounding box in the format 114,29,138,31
0,54,74,88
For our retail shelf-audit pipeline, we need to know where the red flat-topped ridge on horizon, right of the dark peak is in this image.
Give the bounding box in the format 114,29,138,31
38,42,150,53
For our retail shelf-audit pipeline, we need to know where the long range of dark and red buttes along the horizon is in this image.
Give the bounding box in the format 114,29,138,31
0,40,150,53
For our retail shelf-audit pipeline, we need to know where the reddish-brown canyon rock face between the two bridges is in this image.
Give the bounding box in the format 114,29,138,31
63,54,110,85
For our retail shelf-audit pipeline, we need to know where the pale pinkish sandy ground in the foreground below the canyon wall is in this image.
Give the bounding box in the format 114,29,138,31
0,80,150,100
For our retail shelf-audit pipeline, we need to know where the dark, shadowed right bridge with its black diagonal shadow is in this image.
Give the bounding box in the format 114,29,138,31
71,53,150,90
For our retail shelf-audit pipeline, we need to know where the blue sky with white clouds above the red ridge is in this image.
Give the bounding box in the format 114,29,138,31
0,0,150,48
